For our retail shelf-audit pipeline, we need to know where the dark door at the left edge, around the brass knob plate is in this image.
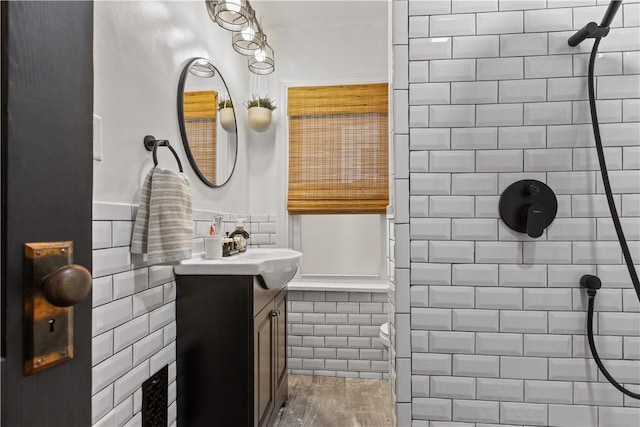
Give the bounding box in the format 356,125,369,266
1,1,93,427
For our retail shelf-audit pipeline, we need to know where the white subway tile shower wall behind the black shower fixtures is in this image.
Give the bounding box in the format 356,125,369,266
393,0,640,427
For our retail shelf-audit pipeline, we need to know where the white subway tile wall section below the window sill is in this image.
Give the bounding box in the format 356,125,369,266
287,291,389,379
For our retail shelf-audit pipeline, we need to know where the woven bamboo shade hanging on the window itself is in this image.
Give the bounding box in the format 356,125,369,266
287,83,389,214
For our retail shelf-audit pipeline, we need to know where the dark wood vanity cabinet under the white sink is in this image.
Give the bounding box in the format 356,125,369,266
176,275,288,427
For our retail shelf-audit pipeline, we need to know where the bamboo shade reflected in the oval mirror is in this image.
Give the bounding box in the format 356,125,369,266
183,91,218,184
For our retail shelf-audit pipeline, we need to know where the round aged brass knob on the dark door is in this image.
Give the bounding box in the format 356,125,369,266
42,264,91,307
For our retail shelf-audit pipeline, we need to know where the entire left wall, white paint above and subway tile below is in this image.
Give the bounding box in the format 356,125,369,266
92,0,258,426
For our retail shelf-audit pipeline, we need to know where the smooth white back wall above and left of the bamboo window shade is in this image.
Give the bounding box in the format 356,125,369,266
247,0,388,214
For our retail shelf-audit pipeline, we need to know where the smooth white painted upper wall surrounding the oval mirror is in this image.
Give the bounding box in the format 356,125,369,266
93,0,250,212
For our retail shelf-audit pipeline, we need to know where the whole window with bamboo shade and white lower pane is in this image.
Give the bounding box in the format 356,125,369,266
287,83,389,281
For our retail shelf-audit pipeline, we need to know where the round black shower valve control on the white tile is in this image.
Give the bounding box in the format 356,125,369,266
499,179,558,238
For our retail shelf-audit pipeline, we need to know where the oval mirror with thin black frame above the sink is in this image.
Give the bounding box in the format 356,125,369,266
178,58,238,188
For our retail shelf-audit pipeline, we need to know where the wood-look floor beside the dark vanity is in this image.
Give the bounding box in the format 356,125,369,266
273,375,393,427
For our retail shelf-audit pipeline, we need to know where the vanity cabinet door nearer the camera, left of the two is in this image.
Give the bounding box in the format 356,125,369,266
253,304,276,426
